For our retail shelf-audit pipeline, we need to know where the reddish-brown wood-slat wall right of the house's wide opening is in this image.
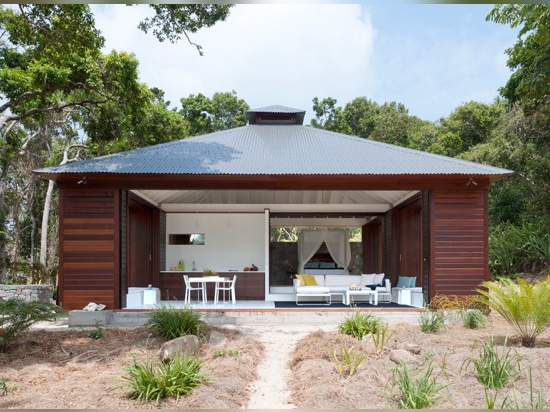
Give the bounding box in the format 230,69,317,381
430,190,489,298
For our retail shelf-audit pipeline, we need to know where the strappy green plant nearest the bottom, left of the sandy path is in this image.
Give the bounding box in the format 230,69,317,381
122,355,208,403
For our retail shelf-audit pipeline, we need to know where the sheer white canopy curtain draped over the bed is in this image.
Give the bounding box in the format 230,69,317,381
298,229,351,275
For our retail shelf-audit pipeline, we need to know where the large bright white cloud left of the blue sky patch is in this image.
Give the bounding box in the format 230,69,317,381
92,4,374,120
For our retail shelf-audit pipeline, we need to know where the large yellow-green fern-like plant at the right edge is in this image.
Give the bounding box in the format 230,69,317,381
477,277,550,347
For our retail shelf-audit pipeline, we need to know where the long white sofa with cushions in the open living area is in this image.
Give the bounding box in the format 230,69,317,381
294,269,391,305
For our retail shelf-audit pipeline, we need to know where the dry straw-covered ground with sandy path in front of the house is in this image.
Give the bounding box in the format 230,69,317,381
0,317,550,409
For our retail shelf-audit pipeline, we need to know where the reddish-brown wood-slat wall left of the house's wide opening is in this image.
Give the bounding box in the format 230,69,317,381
59,190,120,310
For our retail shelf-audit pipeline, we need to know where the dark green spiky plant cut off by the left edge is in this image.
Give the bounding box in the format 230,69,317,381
0,298,61,352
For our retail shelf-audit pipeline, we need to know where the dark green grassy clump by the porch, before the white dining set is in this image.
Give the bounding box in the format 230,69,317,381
145,305,208,340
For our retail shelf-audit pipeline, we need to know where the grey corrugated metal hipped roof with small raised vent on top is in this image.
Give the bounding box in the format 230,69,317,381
35,106,512,180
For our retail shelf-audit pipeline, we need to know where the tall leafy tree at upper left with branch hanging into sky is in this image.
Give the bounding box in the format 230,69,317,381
0,4,231,278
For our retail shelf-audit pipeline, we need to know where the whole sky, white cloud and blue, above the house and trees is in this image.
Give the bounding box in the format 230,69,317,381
90,0,517,123
